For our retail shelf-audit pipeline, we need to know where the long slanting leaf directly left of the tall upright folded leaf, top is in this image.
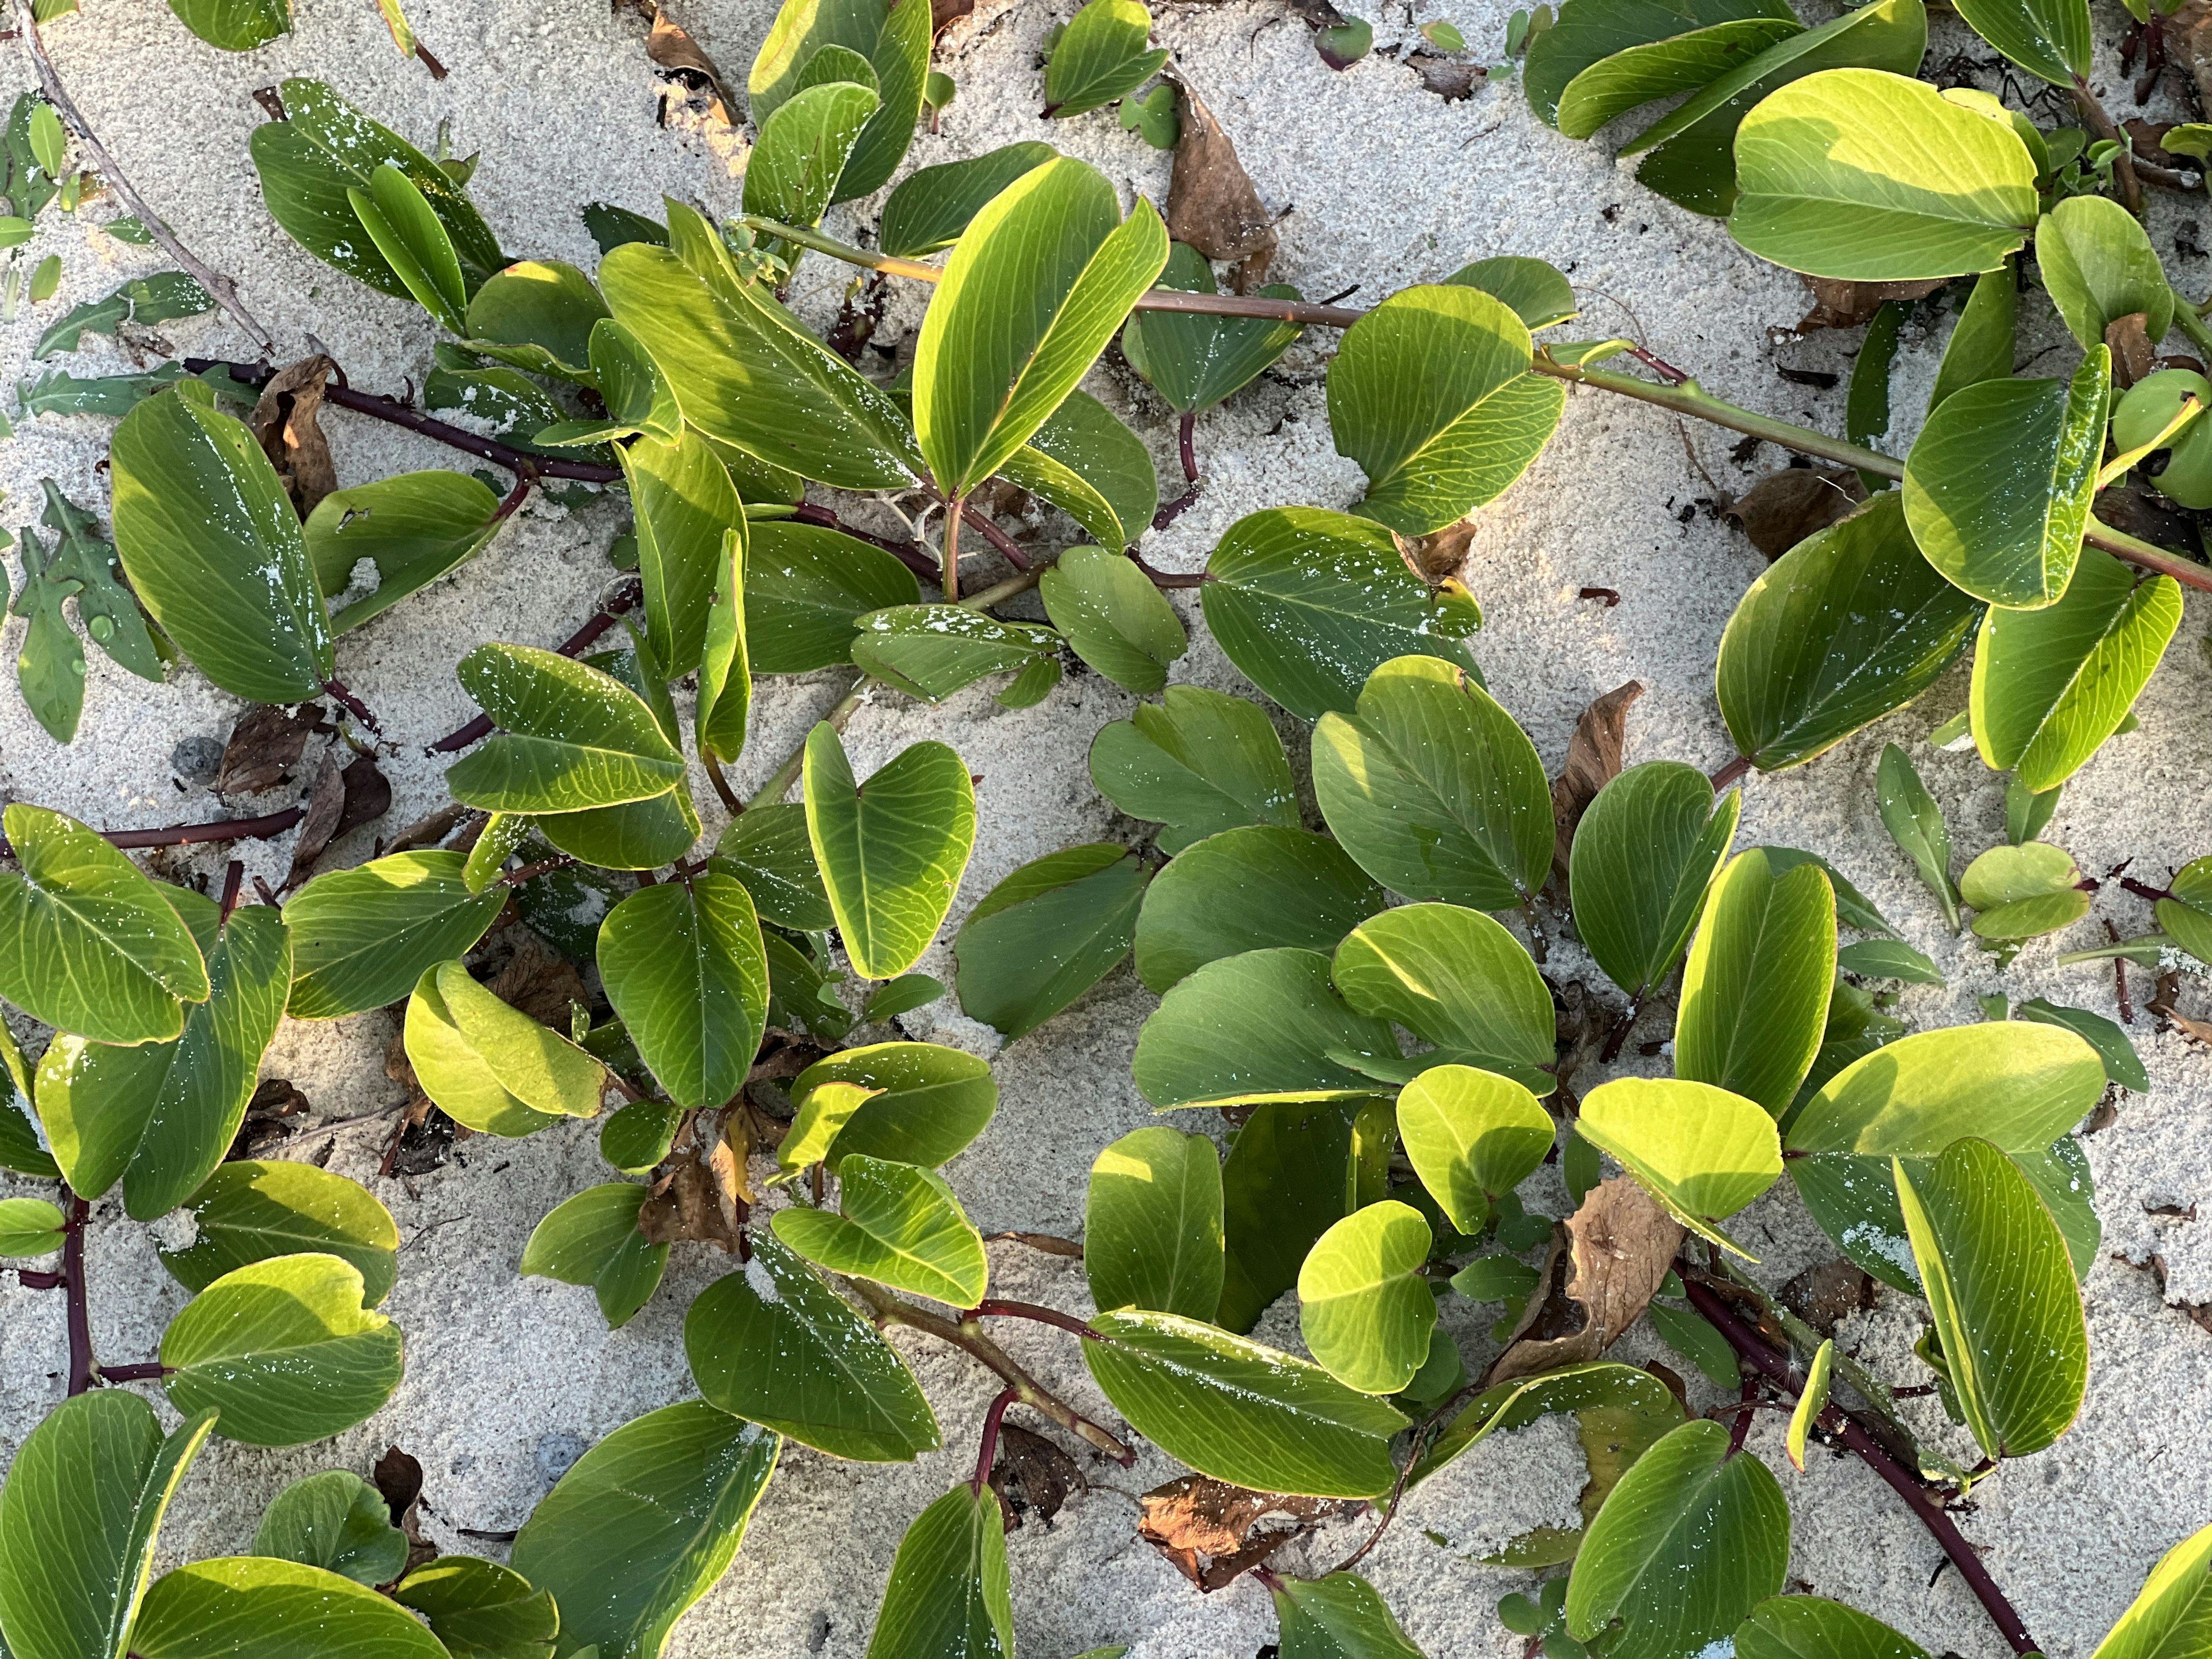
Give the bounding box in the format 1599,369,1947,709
600,215,920,489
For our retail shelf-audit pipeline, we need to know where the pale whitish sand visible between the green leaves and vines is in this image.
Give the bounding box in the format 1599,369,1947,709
0,0,2212,1659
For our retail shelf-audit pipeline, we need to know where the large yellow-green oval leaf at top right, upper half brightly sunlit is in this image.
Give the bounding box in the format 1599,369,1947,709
1725,62,2037,279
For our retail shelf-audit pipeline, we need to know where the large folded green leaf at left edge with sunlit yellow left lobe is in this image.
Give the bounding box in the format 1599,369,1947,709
37,889,292,1221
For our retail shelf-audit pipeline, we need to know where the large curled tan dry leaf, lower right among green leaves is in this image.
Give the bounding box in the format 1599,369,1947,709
1482,1175,1683,1387
